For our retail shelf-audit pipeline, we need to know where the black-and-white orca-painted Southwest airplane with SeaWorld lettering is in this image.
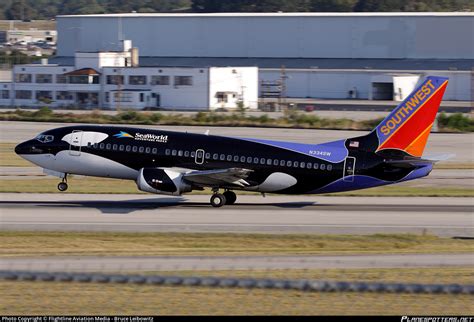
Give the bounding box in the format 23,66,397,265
15,76,448,207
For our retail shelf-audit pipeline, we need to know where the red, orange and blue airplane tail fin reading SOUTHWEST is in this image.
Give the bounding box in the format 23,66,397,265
373,76,448,157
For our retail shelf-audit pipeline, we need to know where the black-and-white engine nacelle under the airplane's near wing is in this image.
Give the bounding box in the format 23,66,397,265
137,168,192,196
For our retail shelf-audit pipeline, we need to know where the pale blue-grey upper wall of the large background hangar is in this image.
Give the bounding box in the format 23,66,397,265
57,12,474,59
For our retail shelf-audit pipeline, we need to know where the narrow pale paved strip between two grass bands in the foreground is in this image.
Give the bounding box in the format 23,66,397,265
0,254,474,272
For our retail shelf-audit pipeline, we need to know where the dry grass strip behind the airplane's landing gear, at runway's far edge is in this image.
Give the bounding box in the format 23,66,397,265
0,176,474,197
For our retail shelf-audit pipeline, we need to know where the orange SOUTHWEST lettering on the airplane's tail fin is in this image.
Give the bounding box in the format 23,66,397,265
380,79,436,136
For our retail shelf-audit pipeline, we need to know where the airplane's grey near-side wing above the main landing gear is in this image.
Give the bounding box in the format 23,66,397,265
183,168,253,187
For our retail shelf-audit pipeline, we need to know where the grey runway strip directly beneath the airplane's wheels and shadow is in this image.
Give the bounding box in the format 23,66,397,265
0,193,474,237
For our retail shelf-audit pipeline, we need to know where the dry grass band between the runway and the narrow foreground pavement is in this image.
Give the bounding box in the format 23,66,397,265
0,231,474,257
